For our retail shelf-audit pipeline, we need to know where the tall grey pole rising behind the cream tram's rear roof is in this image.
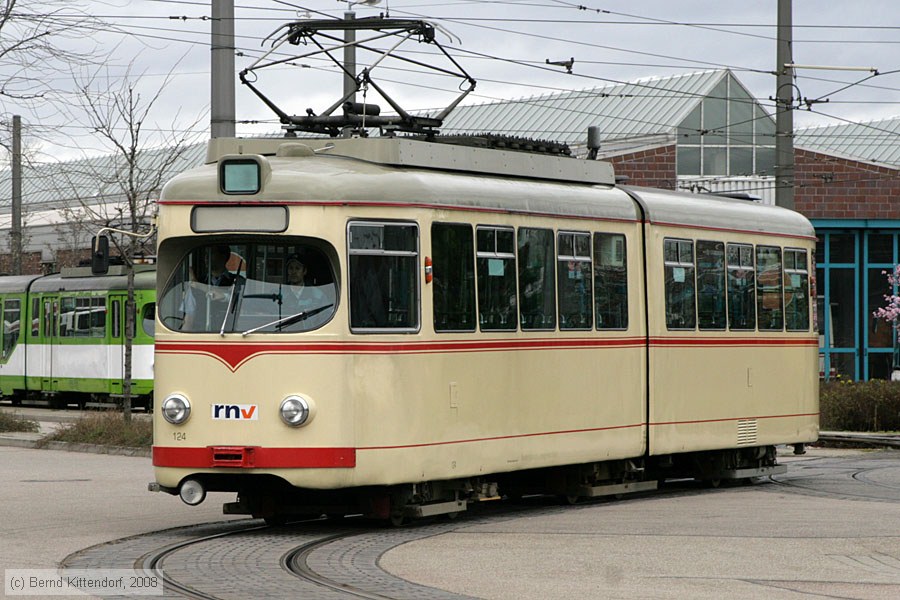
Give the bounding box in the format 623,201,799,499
775,0,794,210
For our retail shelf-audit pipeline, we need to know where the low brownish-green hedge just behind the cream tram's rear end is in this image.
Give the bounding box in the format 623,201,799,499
819,379,900,431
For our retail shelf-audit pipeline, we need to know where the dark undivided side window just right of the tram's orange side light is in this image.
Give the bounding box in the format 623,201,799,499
431,223,475,331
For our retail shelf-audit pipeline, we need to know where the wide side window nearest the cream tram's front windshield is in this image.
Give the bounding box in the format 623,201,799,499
347,222,419,331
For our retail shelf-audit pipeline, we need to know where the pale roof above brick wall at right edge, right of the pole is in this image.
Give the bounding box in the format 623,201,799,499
794,117,900,168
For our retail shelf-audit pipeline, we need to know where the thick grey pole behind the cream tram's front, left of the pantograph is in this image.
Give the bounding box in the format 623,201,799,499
209,0,235,138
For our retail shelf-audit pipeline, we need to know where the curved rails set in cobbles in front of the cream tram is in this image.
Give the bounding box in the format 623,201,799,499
127,511,486,600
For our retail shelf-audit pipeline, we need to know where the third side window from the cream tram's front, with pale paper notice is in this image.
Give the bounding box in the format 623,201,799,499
475,227,518,331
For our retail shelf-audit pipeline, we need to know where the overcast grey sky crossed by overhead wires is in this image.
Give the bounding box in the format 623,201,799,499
0,0,900,162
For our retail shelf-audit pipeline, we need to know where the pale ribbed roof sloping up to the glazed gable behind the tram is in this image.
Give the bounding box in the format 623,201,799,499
441,70,728,144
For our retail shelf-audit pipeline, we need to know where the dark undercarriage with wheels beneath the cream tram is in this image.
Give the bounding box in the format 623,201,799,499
158,445,802,525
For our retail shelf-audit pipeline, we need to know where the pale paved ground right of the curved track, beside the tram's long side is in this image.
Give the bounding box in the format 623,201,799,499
379,450,900,600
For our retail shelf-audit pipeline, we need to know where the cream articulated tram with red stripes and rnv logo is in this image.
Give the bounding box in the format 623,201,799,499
150,138,818,522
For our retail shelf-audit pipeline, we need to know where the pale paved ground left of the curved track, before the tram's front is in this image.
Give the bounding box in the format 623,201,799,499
0,446,243,580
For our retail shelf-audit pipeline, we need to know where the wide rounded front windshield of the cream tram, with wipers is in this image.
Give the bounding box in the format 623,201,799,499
158,240,337,334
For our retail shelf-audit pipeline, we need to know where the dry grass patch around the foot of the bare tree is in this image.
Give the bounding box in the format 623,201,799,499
41,411,153,448
